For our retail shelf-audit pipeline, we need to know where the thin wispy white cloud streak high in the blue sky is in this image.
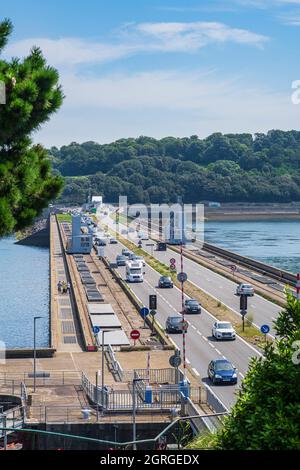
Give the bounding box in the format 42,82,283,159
5,22,268,67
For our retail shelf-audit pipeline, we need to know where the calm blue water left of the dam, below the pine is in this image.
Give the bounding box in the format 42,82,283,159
0,238,49,349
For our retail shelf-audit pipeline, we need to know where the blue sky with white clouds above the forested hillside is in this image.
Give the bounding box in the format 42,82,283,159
0,0,300,147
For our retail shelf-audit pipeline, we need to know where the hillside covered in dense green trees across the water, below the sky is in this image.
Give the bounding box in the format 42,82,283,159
49,130,300,203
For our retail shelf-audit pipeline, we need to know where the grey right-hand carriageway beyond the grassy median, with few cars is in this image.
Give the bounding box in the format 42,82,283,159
105,217,280,335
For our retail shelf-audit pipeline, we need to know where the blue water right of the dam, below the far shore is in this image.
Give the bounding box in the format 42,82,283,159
204,220,300,273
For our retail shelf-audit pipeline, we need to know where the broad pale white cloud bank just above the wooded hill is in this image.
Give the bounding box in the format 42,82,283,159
36,71,300,146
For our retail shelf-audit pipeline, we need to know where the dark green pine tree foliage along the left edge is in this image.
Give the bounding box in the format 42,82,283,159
0,20,63,236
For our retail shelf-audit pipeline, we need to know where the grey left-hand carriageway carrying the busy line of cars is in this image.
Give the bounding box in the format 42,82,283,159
105,237,259,409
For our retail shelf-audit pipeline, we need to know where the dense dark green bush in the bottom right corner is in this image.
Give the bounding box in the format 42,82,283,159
213,294,300,450
